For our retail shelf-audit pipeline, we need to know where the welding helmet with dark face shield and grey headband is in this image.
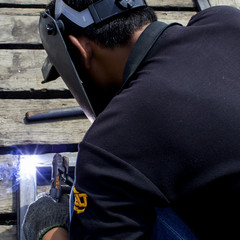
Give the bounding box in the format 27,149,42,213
39,0,146,122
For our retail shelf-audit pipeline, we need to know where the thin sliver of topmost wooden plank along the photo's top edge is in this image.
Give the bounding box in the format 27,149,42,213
0,0,193,7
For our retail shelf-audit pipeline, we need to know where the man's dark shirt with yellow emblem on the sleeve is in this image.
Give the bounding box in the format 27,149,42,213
70,7,240,240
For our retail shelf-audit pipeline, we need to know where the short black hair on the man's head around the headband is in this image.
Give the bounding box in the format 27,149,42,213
48,0,157,48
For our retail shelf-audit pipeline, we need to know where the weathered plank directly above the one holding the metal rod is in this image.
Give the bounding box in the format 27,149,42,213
0,50,67,92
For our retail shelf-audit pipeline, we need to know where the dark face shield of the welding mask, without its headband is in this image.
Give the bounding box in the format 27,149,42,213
39,12,96,122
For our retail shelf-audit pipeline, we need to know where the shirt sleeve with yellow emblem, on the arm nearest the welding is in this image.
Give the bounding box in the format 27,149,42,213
70,142,168,240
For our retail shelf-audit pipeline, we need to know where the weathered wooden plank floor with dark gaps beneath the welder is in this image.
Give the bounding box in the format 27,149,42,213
0,0,240,240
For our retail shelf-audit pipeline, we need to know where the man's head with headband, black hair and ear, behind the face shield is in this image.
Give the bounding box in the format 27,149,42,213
41,0,157,119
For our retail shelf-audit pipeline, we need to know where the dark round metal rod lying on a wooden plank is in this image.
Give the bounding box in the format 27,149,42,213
25,106,86,122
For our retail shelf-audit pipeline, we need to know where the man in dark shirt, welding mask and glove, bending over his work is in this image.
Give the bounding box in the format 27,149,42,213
23,0,240,240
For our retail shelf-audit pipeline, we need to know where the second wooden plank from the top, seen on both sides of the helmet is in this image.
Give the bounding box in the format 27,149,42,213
0,8,194,44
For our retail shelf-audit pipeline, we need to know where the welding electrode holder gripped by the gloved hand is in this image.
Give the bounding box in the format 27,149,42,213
49,153,73,202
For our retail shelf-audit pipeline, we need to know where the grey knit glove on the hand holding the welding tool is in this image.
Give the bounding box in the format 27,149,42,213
23,193,69,240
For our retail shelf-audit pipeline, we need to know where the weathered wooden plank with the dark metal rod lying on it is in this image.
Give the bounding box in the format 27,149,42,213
0,99,90,147
